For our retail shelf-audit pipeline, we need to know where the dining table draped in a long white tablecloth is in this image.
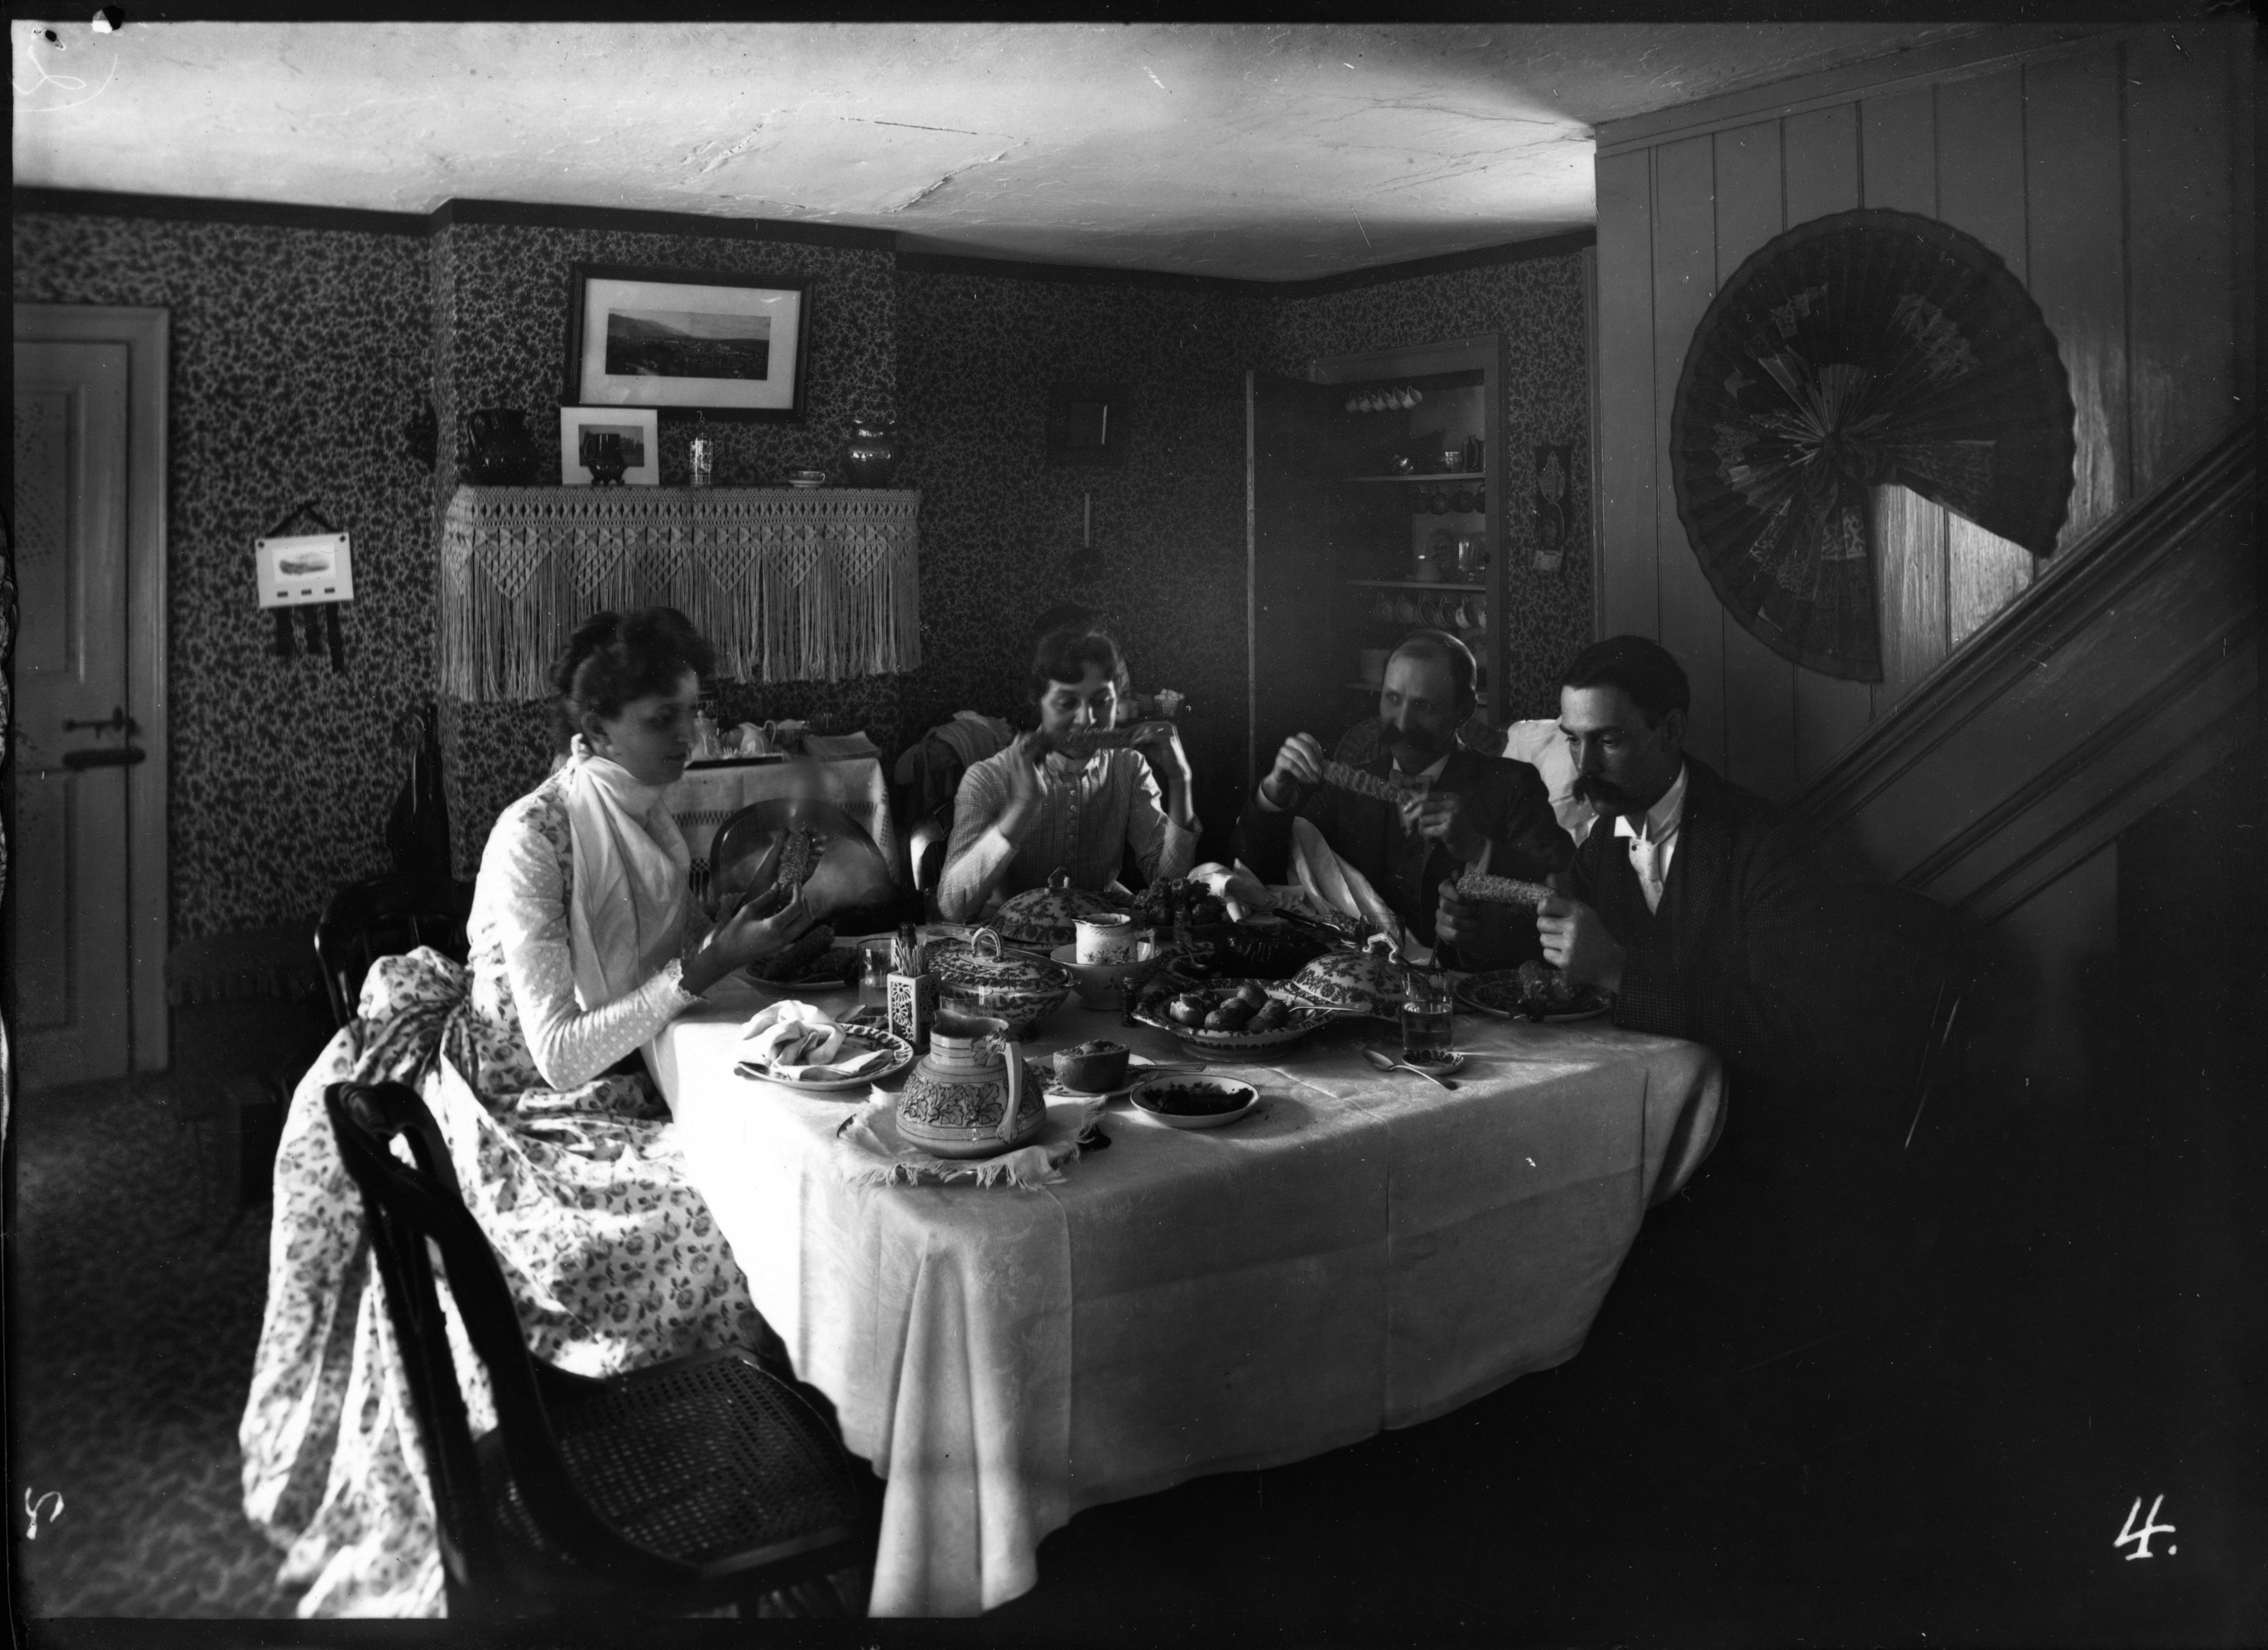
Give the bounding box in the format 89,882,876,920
646,981,1726,1616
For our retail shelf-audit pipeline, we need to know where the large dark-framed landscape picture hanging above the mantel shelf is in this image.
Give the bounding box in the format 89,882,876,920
562,263,810,419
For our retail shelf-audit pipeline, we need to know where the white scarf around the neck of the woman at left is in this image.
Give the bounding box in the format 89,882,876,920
567,737,692,1013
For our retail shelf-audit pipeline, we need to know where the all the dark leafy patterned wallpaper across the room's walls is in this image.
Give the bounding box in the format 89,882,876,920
14,201,1590,938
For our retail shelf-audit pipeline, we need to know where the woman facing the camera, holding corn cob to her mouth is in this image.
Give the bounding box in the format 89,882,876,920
937,628,1200,922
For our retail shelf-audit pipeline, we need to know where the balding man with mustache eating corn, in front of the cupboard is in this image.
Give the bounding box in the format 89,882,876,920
1236,630,1574,968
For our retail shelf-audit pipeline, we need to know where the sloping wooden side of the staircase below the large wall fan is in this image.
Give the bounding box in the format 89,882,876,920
1796,419,2259,927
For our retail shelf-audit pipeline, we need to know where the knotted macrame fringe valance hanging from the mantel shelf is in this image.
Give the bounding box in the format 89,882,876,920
438,488,921,700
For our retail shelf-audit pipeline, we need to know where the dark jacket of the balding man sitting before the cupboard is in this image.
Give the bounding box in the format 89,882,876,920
1236,723,1574,952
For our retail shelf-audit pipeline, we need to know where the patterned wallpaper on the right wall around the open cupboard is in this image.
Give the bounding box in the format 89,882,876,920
1264,252,1592,716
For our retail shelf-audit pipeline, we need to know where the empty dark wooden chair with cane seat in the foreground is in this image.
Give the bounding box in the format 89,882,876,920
324,1083,875,1618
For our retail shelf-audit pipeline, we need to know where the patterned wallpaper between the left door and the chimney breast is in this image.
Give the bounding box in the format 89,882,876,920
14,213,433,938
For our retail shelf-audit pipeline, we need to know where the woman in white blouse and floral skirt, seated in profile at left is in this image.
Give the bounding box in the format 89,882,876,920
238,607,810,1616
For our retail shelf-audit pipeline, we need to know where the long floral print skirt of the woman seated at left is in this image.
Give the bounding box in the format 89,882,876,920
238,950,762,1616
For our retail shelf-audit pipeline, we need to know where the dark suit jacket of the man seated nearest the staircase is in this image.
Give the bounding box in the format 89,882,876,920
1574,757,1957,1310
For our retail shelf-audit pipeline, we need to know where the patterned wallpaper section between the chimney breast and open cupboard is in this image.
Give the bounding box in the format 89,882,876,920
898,270,1256,845
